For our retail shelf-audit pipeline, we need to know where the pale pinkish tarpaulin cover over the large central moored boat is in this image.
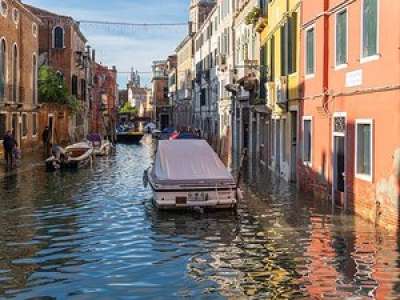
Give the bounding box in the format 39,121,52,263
152,140,235,186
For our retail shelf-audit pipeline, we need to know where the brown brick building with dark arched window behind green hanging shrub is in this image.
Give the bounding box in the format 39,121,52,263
28,6,90,143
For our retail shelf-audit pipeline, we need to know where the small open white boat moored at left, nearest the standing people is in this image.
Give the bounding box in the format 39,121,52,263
45,142,93,171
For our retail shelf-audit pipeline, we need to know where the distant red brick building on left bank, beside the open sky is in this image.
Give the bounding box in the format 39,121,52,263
90,63,118,136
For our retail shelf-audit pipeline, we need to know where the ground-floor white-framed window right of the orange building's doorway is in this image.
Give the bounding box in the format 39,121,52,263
356,120,372,181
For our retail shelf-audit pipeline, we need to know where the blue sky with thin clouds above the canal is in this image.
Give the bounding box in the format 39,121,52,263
23,0,190,87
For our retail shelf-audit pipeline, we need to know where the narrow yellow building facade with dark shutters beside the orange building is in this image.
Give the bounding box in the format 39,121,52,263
258,0,301,182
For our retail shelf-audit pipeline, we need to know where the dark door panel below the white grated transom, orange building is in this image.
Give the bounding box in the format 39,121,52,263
334,136,345,207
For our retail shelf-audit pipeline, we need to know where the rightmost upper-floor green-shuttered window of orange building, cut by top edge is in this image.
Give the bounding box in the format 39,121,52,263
362,0,378,58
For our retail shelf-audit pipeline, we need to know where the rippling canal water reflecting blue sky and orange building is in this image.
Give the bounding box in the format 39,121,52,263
0,139,400,299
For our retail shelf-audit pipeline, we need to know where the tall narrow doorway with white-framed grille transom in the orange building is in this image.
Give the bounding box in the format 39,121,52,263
332,114,346,208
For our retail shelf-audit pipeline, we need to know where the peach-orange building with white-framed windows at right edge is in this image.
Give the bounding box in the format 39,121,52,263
298,0,400,229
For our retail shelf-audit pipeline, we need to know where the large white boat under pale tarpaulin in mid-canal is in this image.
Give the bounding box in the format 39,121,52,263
143,139,240,209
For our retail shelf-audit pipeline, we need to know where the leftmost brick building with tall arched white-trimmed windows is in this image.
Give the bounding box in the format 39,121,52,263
0,0,41,152
